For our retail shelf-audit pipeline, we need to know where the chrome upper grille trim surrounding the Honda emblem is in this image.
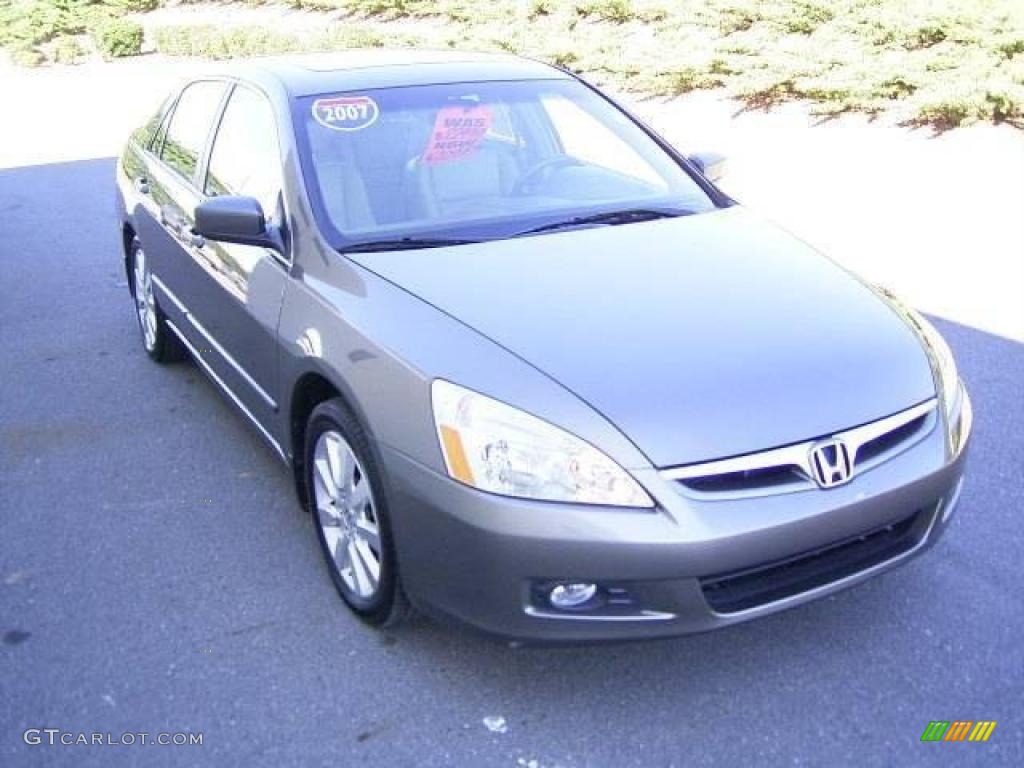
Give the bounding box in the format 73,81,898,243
660,397,938,499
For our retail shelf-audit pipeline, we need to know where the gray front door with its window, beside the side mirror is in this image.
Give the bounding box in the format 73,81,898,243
189,84,290,434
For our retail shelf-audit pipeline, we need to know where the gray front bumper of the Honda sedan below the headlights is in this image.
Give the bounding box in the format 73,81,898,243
381,397,967,642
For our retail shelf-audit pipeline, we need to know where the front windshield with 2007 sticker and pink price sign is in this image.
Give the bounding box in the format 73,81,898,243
297,80,715,249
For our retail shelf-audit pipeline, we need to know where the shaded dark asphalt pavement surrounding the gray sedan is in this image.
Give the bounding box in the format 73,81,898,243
0,159,1024,768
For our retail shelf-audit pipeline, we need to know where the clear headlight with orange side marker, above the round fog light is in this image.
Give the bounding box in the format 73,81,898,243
431,379,654,507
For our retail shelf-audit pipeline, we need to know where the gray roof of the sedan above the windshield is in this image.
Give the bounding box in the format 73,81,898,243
204,48,569,96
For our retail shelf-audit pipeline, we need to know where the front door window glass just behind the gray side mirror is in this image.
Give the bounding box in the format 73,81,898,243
204,85,281,219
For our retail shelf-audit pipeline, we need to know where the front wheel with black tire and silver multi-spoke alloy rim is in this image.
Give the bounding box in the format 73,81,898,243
304,397,408,627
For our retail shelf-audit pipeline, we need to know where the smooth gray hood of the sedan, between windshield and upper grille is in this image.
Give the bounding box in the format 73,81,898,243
354,207,935,467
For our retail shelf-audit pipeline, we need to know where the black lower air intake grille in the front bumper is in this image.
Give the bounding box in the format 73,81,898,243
700,508,934,613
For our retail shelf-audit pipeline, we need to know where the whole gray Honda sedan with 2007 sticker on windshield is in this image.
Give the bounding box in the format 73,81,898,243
117,50,971,642
